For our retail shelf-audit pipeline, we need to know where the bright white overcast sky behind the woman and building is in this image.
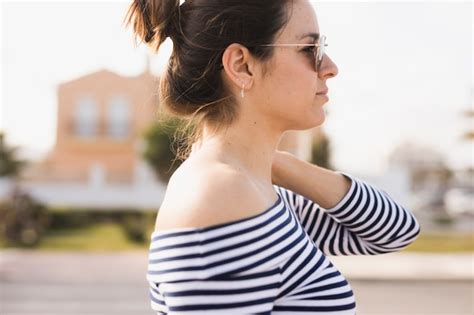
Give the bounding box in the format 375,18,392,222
0,1,474,175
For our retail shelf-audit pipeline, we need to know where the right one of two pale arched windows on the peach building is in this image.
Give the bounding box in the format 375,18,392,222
107,95,130,139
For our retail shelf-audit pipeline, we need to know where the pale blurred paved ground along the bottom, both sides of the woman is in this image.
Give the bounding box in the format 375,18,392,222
0,251,474,315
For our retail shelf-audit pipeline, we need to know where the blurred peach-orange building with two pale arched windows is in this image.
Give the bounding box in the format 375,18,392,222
22,70,158,183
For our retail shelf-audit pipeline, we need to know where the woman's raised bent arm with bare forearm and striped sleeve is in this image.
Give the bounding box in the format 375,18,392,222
273,152,420,255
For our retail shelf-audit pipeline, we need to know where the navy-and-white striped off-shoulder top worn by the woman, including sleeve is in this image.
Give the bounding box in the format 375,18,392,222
147,172,420,315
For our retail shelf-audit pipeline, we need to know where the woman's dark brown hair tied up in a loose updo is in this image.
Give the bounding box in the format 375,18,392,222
126,0,292,159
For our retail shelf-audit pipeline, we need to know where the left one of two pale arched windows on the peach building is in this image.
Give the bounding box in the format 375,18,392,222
74,96,99,138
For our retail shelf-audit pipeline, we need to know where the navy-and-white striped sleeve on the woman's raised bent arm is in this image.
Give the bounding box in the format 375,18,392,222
274,172,420,255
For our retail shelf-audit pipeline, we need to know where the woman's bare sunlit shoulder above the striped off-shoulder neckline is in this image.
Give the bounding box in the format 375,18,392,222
155,158,276,231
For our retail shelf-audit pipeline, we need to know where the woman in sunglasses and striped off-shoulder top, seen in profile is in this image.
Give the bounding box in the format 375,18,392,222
128,0,420,314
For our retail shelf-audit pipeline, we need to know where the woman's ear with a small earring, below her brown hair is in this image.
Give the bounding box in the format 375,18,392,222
222,43,258,89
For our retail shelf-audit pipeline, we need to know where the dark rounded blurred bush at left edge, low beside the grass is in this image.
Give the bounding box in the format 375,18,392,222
0,189,49,247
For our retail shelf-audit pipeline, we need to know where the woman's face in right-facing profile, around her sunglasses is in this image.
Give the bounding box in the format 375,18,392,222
255,0,338,130
